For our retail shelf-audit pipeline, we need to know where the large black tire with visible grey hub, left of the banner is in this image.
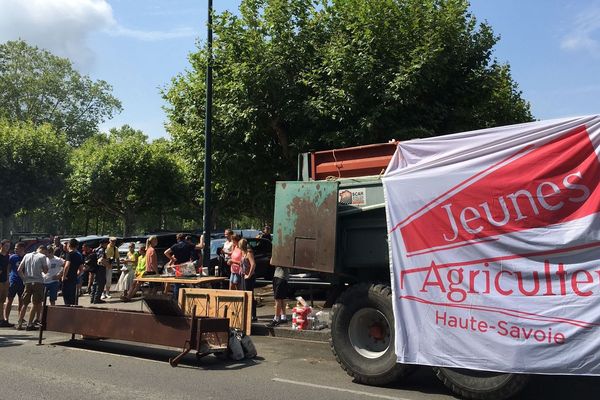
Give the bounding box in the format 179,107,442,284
330,283,415,385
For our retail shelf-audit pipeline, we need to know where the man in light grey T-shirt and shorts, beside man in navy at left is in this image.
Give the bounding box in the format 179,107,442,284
17,246,48,331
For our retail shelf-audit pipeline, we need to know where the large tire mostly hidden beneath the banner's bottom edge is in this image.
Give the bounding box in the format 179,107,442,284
435,368,530,400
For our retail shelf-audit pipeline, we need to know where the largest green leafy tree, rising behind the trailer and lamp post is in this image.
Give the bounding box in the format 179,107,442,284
164,0,532,219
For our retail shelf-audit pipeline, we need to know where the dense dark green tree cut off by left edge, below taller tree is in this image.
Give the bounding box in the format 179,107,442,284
0,118,70,238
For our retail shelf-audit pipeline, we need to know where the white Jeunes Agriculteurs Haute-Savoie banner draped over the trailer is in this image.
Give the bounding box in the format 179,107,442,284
383,116,600,375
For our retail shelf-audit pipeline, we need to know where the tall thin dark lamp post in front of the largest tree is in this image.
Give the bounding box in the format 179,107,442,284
202,0,213,268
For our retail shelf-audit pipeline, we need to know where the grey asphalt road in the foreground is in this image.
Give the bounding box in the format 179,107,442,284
0,329,600,400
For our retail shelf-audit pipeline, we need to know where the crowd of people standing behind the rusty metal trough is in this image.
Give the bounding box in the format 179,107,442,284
0,227,278,331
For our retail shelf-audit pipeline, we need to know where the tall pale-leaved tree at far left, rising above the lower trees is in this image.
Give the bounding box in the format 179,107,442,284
0,40,121,146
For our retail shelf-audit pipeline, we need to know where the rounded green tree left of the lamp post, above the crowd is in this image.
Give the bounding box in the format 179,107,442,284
68,125,187,236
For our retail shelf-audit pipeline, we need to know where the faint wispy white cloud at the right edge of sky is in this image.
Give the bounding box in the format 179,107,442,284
560,6,600,56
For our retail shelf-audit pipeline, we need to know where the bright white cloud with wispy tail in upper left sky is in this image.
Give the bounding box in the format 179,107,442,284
0,0,196,69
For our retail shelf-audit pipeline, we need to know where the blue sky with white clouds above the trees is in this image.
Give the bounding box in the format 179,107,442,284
0,0,600,138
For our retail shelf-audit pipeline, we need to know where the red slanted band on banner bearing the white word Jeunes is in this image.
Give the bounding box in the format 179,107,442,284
395,126,600,253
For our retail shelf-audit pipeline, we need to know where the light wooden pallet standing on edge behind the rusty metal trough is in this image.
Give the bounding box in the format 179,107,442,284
179,288,252,335
